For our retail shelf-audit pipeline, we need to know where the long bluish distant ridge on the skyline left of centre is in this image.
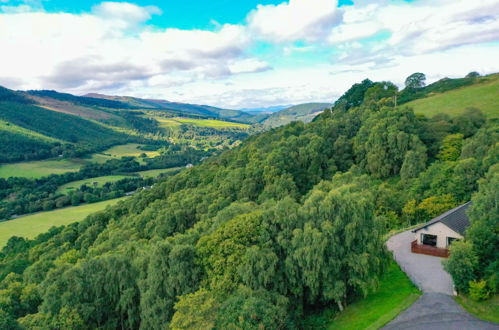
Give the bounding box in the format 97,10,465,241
83,93,252,123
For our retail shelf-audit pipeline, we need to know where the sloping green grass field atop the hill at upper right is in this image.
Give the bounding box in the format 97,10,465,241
404,77,499,118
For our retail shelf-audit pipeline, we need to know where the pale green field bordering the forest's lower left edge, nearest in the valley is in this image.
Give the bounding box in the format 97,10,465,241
0,197,126,248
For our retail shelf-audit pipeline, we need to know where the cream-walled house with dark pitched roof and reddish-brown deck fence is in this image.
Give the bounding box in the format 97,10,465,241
411,202,471,257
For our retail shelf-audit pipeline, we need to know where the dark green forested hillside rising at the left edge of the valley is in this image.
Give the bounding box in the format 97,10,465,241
0,87,133,163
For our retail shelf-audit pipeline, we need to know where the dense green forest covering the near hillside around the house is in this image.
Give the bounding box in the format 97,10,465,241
0,76,499,329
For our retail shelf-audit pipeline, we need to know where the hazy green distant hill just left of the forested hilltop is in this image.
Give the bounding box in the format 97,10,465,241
261,103,332,127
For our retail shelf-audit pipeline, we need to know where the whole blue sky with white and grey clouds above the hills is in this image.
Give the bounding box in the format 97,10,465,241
0,0,499,108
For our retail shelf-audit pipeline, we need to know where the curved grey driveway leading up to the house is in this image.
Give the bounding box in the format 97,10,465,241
383,231,499,330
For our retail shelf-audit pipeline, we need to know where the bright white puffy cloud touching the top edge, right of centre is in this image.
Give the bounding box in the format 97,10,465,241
248,0,341,42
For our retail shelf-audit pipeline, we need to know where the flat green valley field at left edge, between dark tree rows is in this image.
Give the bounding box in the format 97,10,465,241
0,159,85,179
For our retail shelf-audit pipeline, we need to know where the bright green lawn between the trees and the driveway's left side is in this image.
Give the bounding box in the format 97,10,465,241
304,261,421,330
